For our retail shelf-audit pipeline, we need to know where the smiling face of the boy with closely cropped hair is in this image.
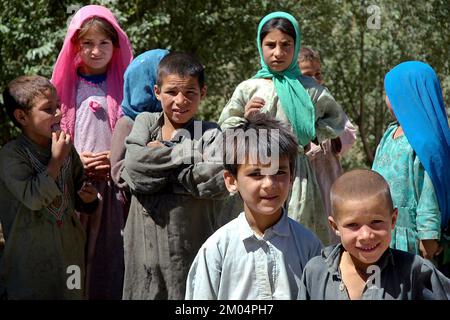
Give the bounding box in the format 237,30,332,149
328,196,397,266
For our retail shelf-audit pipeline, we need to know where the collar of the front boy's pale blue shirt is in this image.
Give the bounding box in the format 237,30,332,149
238,208,290,241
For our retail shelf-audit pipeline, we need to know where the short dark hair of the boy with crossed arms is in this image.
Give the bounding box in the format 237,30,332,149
156,52,205,88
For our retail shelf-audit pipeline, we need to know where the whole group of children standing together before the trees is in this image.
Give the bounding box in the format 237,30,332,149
0,5,450,299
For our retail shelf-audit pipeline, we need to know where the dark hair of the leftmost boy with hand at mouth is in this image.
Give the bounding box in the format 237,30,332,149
3,75,56,127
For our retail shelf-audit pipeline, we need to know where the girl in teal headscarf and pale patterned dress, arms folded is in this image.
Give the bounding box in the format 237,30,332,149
218,12,346,245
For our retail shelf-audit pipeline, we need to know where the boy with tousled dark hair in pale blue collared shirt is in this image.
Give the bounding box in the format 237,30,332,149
185,113,322,300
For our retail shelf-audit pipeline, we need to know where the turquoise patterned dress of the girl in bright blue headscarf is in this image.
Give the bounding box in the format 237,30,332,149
372,123,441,254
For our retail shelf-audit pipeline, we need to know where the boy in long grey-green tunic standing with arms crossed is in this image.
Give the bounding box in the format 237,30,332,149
122,53,228,299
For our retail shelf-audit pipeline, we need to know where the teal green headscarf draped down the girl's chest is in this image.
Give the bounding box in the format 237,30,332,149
253,12,316,146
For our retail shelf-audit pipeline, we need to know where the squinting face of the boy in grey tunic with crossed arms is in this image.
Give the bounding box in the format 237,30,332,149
155,74,206,128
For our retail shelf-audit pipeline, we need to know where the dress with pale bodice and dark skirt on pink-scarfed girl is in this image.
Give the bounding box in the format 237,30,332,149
74,75,124,299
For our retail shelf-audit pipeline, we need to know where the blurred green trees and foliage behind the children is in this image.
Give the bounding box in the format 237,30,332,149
0,0,450,169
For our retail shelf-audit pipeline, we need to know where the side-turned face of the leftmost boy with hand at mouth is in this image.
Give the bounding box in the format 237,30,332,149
14,90,61,147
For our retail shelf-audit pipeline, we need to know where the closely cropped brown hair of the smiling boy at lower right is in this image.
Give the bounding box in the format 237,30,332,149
330,169,394,216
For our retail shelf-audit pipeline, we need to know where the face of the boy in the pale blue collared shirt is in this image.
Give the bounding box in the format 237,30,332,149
224,157,292,219
